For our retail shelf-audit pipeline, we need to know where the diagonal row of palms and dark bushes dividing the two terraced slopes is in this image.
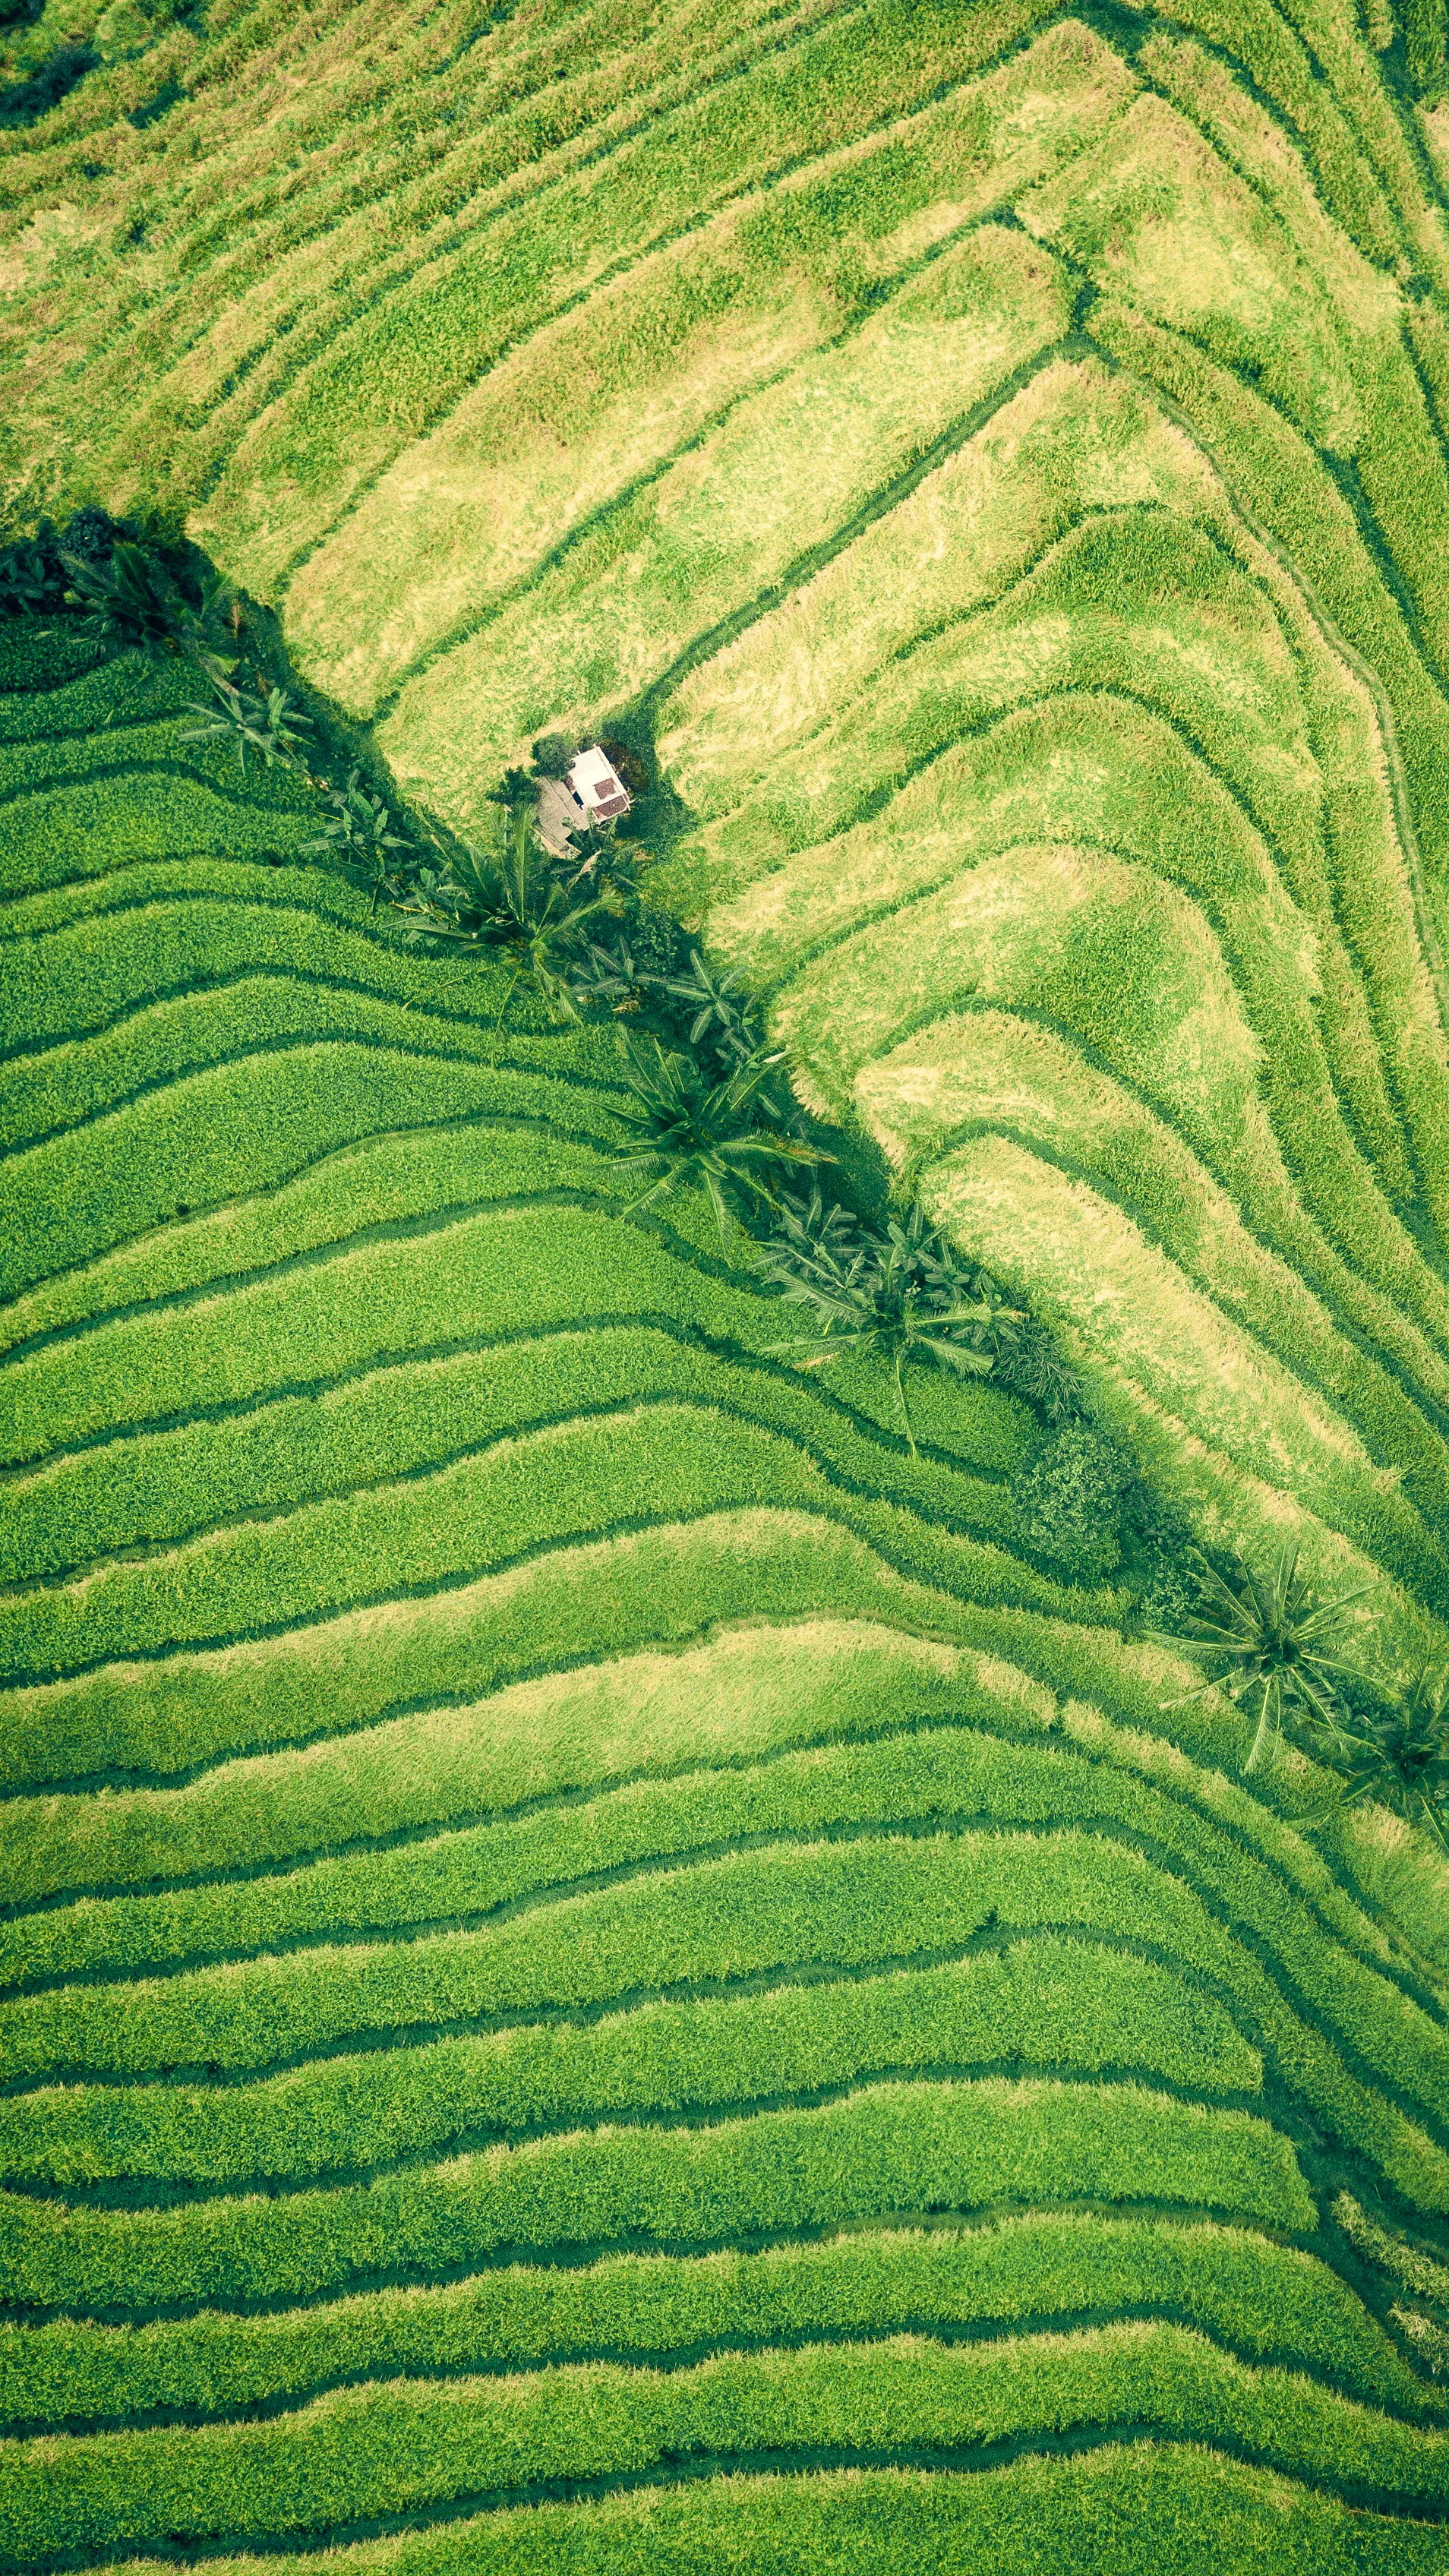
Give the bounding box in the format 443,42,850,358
0,507,1449,1852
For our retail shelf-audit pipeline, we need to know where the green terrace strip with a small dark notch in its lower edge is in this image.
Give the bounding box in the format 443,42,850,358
0,1832,1274,2079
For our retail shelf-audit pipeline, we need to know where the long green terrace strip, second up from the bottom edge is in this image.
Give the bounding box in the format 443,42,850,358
17,2324,1447,2563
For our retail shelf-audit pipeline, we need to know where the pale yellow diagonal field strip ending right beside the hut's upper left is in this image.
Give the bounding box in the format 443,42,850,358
379,226,1070,827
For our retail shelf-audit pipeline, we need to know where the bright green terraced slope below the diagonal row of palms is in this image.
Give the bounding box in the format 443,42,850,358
0,646,1449,2565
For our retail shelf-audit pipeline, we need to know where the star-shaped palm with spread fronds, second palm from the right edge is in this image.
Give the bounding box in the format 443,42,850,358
1155,1540,1369,1773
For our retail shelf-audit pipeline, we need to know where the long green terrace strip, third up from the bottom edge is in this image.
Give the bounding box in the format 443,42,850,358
0,2213,1441,2421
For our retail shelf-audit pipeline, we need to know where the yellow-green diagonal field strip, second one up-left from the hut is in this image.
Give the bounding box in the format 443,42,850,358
286,28,1132,714
